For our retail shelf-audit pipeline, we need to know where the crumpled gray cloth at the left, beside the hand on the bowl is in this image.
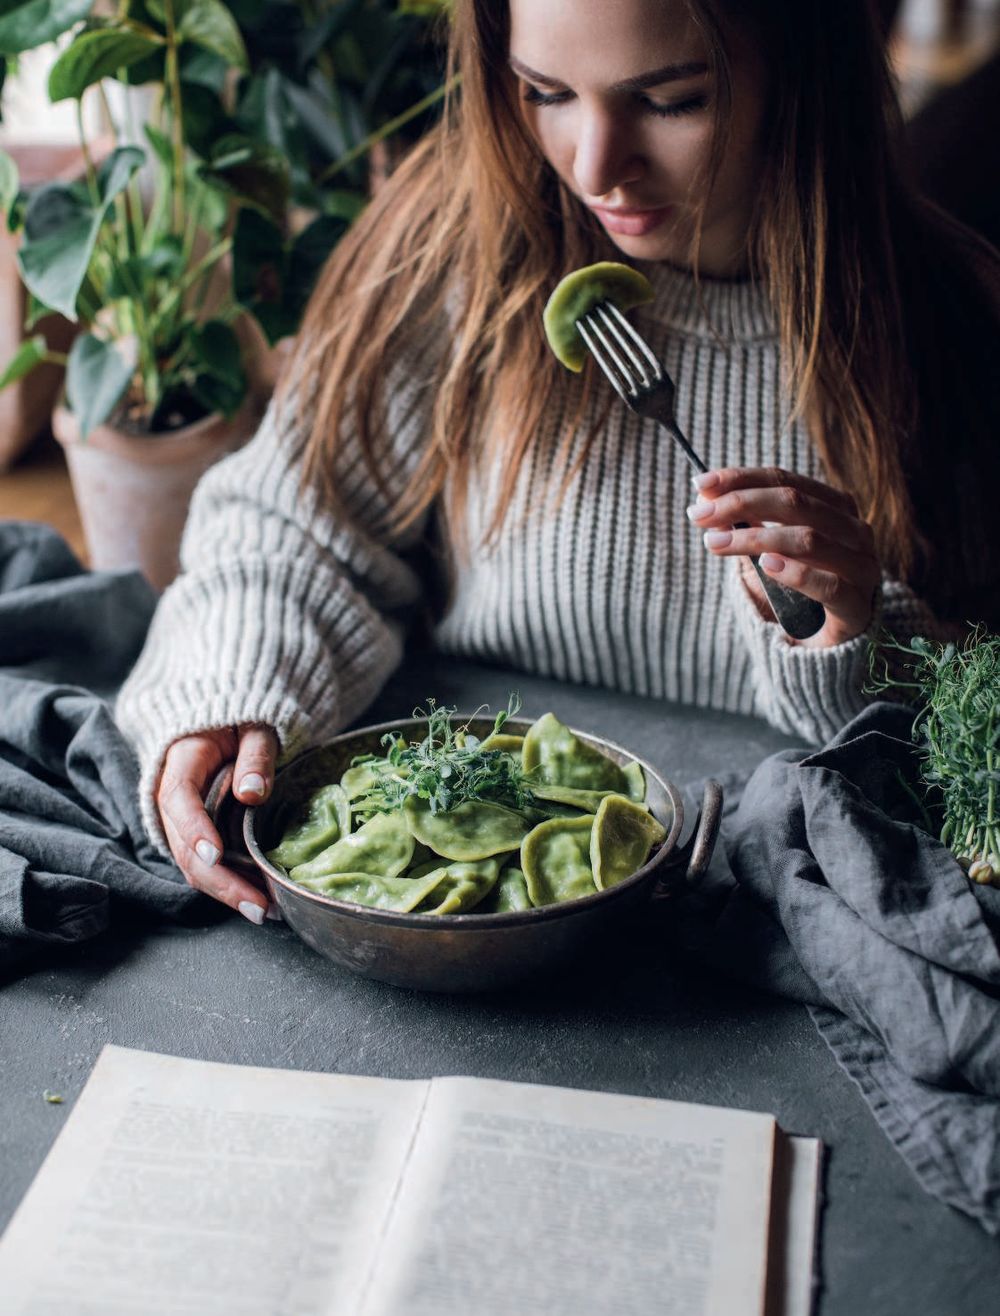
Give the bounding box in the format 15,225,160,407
0,521,204,976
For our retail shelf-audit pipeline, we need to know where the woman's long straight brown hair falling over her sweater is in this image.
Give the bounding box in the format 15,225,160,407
284,0,1000,625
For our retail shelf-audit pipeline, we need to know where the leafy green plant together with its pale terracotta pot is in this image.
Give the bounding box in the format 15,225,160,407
0,0,450,587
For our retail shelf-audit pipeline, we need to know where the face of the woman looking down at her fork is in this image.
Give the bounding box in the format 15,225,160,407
511,0,763,276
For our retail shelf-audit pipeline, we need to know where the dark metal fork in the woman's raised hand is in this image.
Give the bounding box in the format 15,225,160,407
576,301,826,640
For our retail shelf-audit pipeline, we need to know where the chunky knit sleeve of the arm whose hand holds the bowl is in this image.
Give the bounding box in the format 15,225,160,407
116,355,430,846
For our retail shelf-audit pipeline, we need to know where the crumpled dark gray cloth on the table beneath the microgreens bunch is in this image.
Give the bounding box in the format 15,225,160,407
684,703,1000,1234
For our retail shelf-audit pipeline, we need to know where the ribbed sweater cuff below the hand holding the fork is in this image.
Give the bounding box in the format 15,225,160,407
728,561,954,745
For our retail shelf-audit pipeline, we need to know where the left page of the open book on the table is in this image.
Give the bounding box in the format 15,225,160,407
0,1046,429,1316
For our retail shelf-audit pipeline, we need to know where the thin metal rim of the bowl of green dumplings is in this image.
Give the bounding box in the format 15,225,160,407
242,712,684,932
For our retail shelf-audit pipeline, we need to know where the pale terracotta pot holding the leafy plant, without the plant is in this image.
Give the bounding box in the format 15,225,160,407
53,404,259,590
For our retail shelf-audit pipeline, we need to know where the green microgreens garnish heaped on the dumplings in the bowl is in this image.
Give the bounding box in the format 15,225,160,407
355,695,533,813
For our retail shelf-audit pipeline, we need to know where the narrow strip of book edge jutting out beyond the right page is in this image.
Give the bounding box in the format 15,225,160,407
767,1132,822,1316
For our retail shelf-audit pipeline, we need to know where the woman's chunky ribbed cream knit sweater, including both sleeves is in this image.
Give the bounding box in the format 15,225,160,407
117,266,934,845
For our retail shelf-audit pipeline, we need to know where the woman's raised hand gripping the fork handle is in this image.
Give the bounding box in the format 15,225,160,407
688,466,882,649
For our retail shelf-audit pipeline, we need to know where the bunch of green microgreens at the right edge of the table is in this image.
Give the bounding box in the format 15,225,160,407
871,628,1000,884
